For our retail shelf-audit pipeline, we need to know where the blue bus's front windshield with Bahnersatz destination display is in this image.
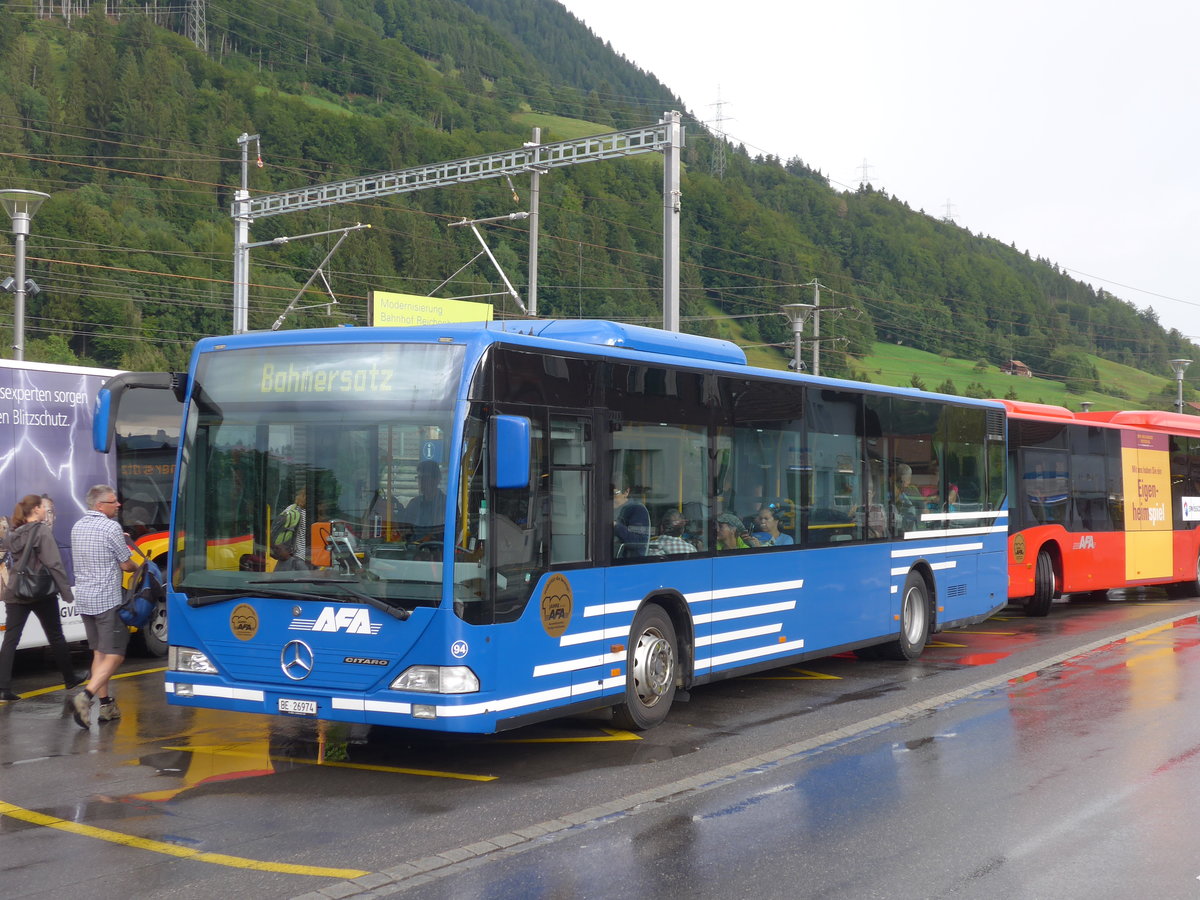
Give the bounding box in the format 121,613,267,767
173,343,464,608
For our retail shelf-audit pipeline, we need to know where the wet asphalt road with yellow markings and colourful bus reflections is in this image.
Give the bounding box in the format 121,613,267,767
0,595,1200,899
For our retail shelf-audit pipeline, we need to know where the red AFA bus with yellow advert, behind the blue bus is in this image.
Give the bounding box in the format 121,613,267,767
1002,400,1200,616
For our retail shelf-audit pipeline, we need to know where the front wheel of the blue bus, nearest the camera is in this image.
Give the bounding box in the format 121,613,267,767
613,604,679,731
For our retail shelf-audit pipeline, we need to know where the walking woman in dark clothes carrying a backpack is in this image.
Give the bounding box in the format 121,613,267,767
0,493,88,701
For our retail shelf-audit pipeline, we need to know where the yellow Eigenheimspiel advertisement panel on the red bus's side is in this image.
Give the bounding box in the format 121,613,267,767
1121,431,1172,582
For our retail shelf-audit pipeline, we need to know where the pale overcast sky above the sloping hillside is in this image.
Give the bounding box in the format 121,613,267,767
562,0,1200,348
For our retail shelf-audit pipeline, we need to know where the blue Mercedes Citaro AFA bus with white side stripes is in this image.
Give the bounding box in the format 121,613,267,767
97,320,1008,733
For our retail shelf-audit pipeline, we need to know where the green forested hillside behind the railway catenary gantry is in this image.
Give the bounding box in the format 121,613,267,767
0,0,1200,400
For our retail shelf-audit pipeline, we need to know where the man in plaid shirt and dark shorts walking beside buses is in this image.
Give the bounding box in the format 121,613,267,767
71,485,137,728
